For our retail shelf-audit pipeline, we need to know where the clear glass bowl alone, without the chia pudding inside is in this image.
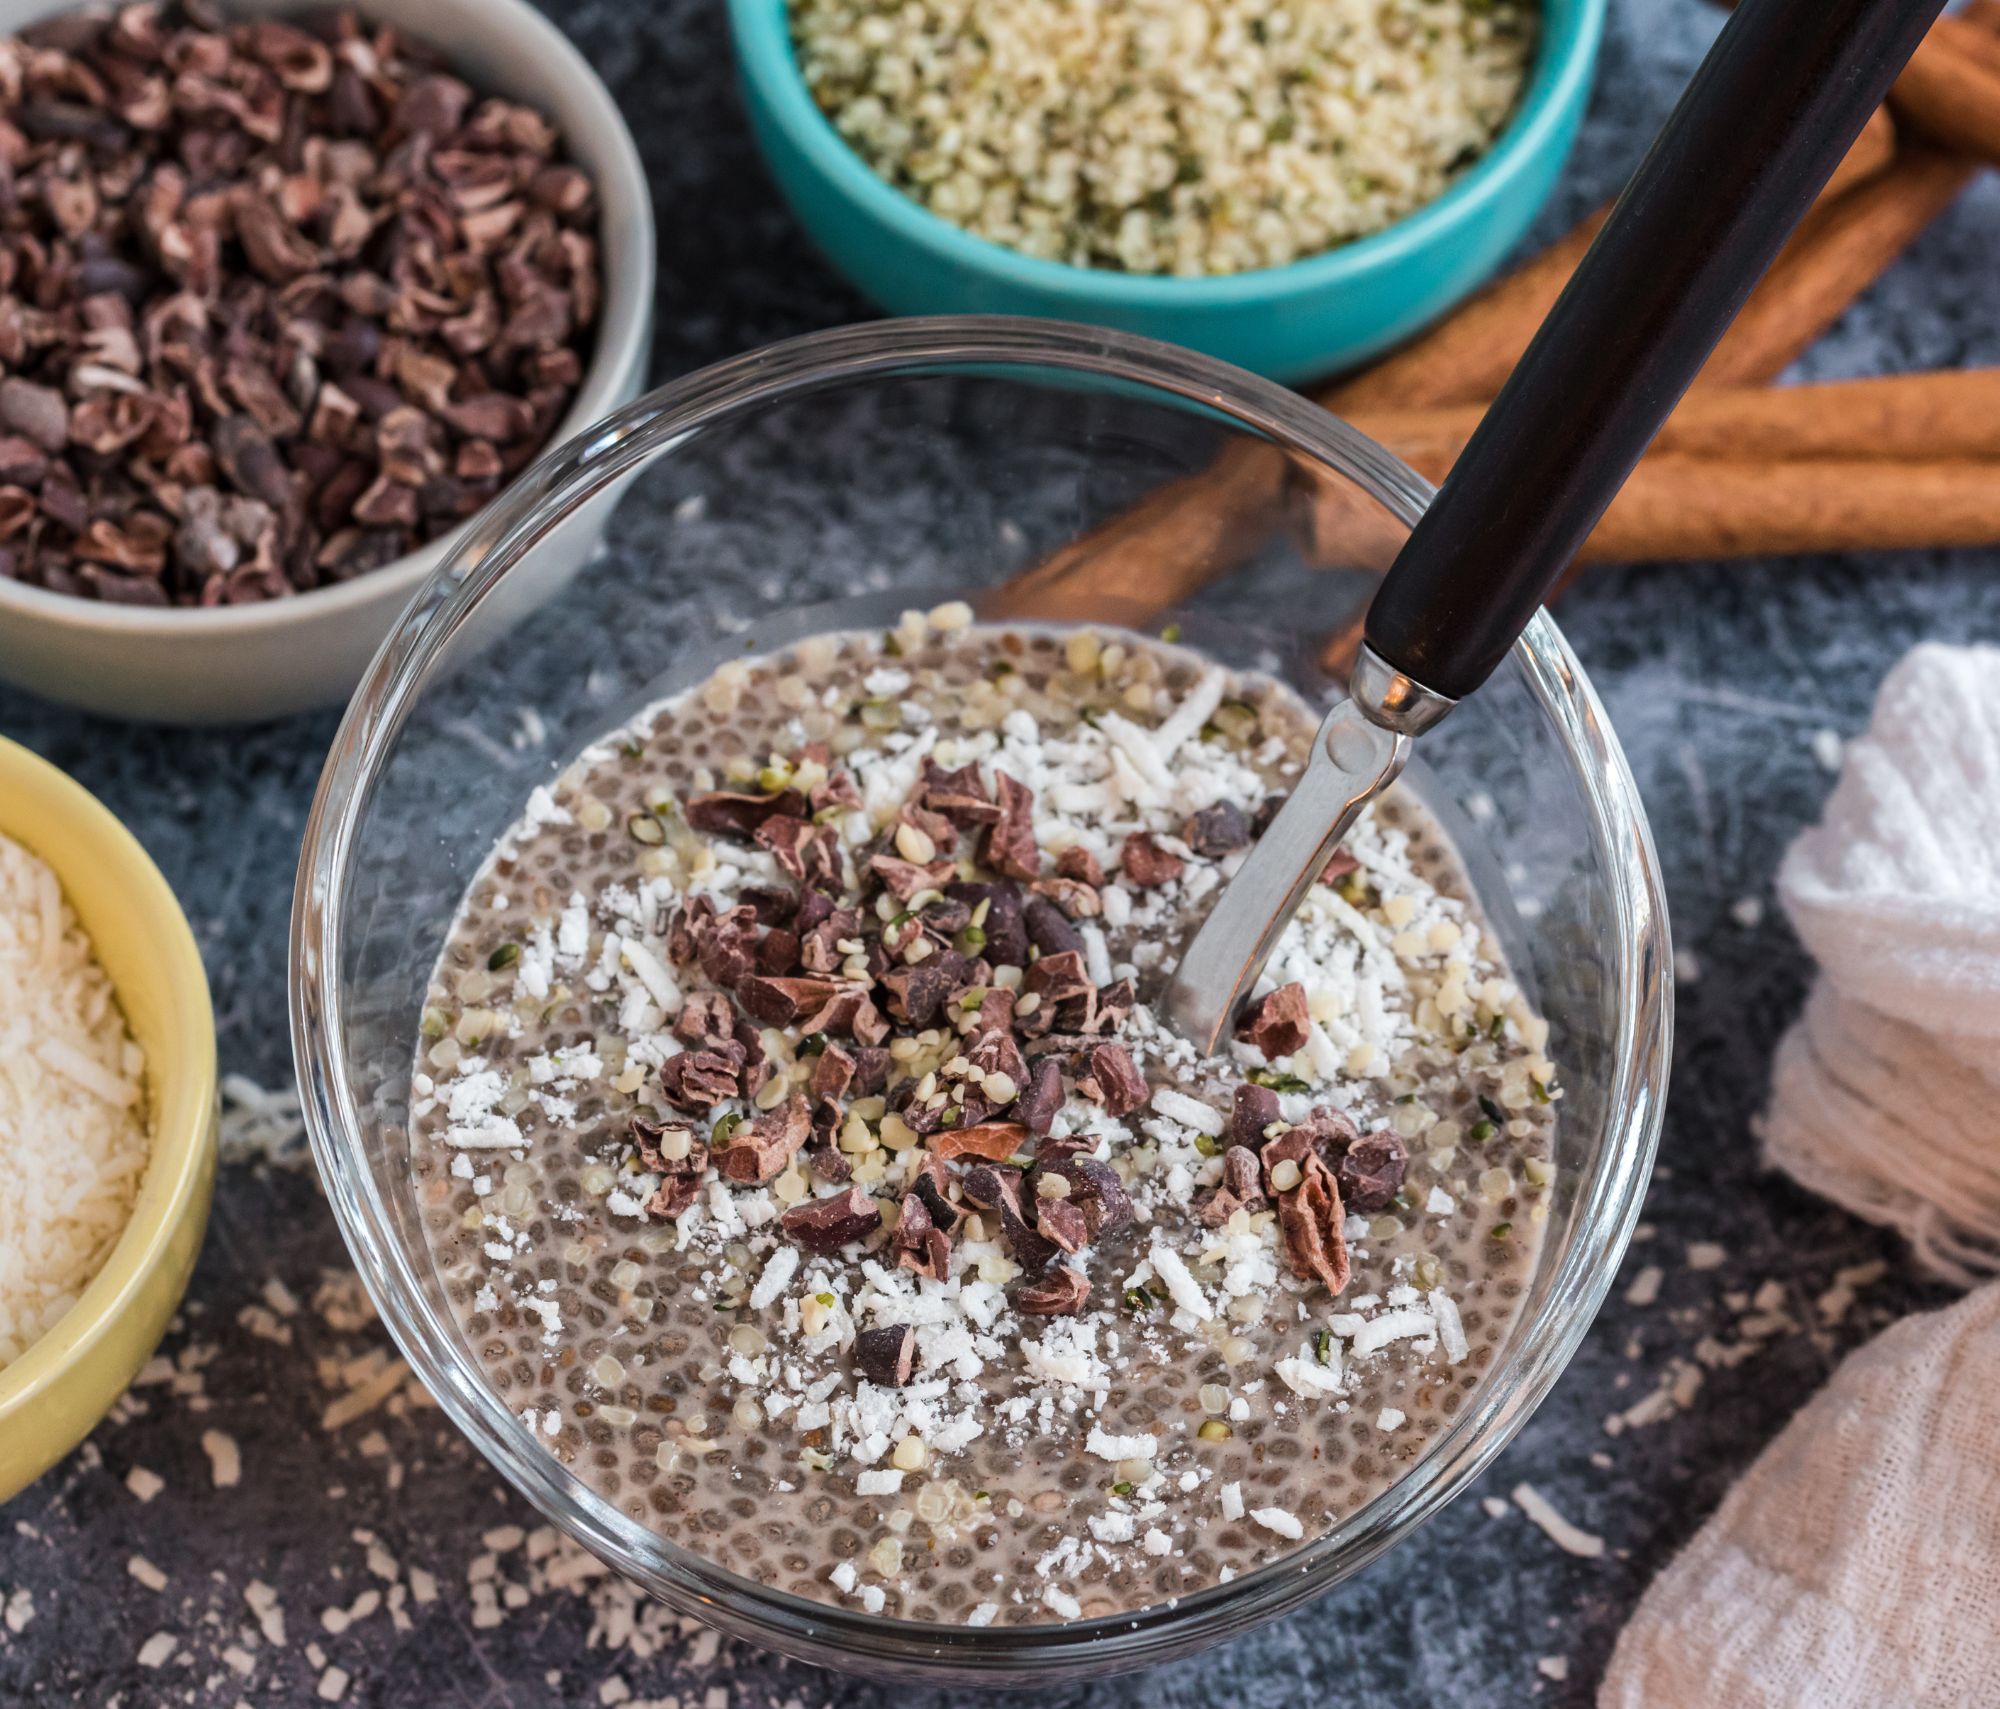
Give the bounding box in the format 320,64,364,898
290,318,1672,1683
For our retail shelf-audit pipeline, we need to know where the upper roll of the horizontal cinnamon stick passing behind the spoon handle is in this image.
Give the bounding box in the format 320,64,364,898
1352,368,2000,482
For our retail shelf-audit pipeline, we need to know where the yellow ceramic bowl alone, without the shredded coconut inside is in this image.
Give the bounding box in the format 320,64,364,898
0,736,216,1501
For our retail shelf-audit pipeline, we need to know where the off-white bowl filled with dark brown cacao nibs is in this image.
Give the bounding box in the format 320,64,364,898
0,0,654,722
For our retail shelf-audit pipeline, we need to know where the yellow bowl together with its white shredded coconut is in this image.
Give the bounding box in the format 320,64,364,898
0,738,216,1501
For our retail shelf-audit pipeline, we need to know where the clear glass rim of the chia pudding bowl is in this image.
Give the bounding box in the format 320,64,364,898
290,316,1672,1683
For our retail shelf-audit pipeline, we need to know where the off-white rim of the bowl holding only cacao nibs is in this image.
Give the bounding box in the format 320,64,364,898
0,0,660,636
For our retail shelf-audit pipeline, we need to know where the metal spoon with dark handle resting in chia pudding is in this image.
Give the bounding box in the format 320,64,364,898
1166,0,1944,1055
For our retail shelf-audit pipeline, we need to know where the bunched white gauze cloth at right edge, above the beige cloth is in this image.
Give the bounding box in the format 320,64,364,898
1764,644,2000,1280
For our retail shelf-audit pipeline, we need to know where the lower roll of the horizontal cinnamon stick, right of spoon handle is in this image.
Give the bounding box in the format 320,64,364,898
1582,456,2000,562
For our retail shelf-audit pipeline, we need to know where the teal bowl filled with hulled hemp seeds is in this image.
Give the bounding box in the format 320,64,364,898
730,0,1604,382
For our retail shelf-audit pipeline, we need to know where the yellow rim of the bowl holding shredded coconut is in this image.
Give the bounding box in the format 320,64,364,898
0,736,216,1429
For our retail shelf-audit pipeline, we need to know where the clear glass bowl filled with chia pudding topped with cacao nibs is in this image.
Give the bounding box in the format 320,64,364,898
290,318,1670,1685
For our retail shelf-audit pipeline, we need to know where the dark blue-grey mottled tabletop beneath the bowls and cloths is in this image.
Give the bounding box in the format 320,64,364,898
0,0,2000,1709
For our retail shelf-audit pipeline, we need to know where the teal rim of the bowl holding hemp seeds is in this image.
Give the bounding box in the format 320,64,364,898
726,0,1608,310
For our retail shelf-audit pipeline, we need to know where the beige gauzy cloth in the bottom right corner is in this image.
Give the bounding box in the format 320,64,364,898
1598,1283,2000,1709
